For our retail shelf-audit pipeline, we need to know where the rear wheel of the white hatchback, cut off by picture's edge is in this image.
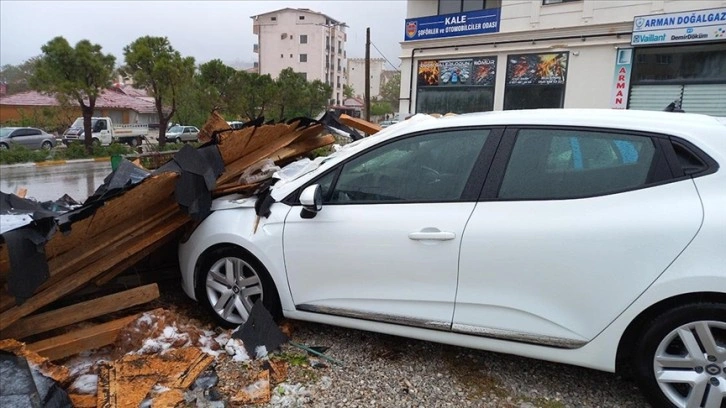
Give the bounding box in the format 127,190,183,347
634,303,726,408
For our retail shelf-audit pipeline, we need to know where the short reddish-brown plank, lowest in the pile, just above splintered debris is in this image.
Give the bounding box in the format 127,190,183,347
28,315,138,360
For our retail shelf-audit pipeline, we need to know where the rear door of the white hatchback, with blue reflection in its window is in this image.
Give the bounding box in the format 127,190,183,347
453,127,702,348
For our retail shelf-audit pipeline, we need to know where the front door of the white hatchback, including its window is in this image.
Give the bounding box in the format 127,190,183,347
283,129,498,330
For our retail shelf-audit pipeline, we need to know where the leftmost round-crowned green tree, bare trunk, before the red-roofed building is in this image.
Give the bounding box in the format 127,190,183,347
29,37,116,152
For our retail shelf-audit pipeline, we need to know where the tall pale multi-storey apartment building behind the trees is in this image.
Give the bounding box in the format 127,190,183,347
252,8,347,105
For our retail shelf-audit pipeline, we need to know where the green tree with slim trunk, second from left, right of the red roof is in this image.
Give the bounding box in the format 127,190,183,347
122,36,194,146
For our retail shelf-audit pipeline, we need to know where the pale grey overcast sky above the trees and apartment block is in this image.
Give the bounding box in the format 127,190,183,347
0,0,406,68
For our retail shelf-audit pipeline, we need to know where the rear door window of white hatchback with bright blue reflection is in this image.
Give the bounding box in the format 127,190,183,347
499,129,655,199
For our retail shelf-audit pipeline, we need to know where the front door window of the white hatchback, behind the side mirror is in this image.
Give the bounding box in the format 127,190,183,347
326,129,489,203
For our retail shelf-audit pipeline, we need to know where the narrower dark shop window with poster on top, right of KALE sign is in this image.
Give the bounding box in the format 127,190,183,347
504,52,568,110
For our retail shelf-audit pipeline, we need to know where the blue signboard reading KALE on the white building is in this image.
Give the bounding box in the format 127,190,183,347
403,8,500,41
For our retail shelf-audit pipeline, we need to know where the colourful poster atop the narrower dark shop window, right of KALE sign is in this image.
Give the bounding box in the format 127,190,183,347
507,52,568,85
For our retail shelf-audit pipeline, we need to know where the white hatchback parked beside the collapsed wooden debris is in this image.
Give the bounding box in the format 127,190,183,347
179,109,726,407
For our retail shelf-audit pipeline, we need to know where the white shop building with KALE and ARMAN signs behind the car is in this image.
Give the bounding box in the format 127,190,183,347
399,0,726,116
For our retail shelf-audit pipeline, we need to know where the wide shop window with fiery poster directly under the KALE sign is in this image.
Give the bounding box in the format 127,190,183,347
416,56,497,114
